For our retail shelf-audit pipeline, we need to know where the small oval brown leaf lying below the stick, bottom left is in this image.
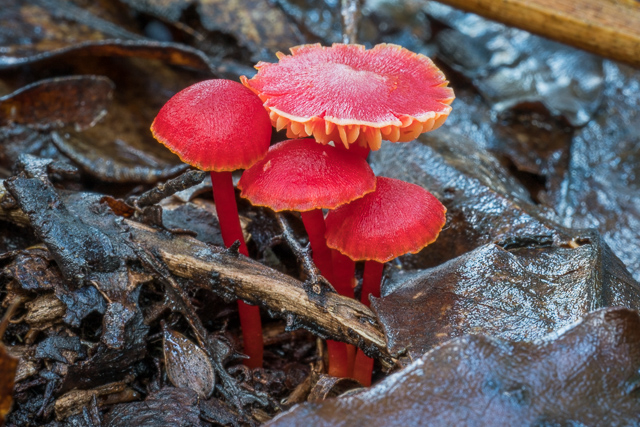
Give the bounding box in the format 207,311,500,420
163,328,216,399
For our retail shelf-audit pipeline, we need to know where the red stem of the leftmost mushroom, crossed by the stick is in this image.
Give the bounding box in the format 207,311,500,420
211,171,264,369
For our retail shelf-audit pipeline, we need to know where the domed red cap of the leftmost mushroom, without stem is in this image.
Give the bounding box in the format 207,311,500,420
151,79,272,172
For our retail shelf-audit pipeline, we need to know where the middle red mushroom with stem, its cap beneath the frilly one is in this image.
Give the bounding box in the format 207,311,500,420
238,139,376,376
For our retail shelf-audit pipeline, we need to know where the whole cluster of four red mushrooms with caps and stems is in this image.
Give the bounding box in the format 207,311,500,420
151,44,454,386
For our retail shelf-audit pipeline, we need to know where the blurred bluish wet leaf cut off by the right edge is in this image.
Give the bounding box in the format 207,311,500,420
553,62,640,280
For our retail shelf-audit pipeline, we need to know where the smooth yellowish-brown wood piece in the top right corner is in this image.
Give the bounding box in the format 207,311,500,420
438,0,640,67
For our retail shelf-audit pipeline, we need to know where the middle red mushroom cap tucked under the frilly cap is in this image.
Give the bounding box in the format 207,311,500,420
238,139,376,212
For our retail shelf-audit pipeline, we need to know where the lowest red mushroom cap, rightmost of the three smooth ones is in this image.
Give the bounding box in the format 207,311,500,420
325,177,447,262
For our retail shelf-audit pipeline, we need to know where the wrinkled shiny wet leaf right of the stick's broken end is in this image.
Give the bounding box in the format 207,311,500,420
371,239,640,357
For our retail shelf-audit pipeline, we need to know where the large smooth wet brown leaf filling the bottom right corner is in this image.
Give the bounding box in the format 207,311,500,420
267,308,640,427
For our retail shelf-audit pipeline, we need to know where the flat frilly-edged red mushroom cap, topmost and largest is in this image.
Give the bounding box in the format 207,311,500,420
240,43,454,150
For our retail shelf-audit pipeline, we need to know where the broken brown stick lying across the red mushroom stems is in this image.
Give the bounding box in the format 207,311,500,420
124,220,394,365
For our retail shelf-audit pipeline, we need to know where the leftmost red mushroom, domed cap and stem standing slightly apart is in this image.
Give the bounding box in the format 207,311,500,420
151,80,271,368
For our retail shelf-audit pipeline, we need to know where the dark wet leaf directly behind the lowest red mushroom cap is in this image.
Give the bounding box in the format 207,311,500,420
371,129,574,268
